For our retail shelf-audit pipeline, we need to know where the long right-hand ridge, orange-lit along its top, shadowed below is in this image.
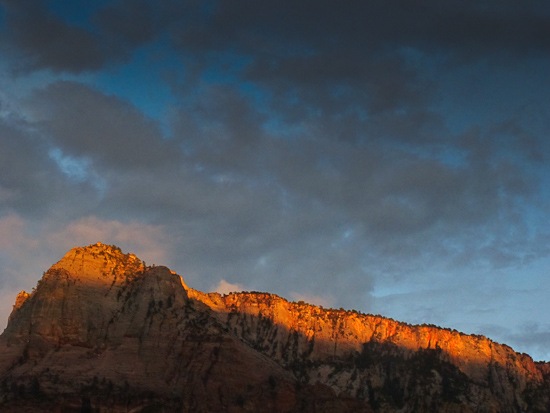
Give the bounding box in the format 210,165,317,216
201,291,548,412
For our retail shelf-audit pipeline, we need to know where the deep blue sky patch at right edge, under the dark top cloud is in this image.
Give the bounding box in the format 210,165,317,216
424,58,550,174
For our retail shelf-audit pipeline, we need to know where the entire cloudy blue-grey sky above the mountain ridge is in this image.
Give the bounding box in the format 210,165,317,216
0,0,550,360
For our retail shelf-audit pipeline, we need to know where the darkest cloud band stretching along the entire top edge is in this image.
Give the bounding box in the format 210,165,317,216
2,0,550,75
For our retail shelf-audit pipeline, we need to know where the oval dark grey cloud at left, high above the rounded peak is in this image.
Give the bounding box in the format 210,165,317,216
28,81,179,169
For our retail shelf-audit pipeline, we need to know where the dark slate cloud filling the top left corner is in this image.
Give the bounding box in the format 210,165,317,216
0,0,181,73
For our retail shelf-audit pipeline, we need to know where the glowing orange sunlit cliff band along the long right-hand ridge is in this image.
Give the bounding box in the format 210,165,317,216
190,291,542,380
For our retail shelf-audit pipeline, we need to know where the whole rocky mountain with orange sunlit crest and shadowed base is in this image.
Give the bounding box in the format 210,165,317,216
0,243,550,413
